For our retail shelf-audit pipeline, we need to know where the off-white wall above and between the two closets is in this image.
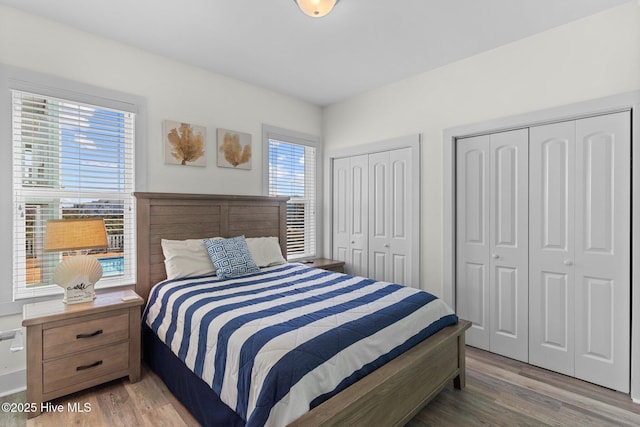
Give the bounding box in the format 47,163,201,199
324,2,640,295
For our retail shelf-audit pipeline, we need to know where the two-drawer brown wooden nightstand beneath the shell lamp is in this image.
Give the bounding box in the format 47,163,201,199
22,290,144,418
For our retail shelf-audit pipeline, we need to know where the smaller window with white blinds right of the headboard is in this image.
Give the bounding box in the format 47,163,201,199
263,126,318,259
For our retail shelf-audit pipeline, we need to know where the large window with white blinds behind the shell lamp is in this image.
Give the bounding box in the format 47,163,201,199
11,89,135,299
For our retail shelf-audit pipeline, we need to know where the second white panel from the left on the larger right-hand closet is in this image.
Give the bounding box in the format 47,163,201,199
489,129,529,362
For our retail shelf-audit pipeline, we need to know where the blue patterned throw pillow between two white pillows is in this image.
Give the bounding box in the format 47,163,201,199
204,236,260,279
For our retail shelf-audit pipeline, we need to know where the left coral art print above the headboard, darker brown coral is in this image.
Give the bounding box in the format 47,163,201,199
162,120,207,167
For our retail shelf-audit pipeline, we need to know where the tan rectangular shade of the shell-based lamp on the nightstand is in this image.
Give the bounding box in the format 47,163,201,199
44,218,108,252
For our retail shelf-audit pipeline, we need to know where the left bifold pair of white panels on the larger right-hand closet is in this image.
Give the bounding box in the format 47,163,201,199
456,129,528,361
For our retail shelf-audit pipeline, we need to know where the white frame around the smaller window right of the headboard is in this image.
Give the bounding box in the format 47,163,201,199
262,124,323,261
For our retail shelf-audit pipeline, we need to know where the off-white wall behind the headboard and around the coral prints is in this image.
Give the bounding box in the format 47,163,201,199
0,6,322,388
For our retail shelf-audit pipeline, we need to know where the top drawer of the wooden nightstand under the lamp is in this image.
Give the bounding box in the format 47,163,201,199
42,310,129,360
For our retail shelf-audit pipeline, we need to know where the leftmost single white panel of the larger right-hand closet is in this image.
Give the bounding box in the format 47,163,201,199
456,135,491,350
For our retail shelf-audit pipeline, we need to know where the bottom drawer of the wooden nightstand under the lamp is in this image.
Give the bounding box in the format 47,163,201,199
42,341,129,393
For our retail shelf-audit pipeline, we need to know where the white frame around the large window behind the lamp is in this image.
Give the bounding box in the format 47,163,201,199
0,64,147,306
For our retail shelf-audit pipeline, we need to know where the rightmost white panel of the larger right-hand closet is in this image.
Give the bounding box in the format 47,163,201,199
574,112,631,393
